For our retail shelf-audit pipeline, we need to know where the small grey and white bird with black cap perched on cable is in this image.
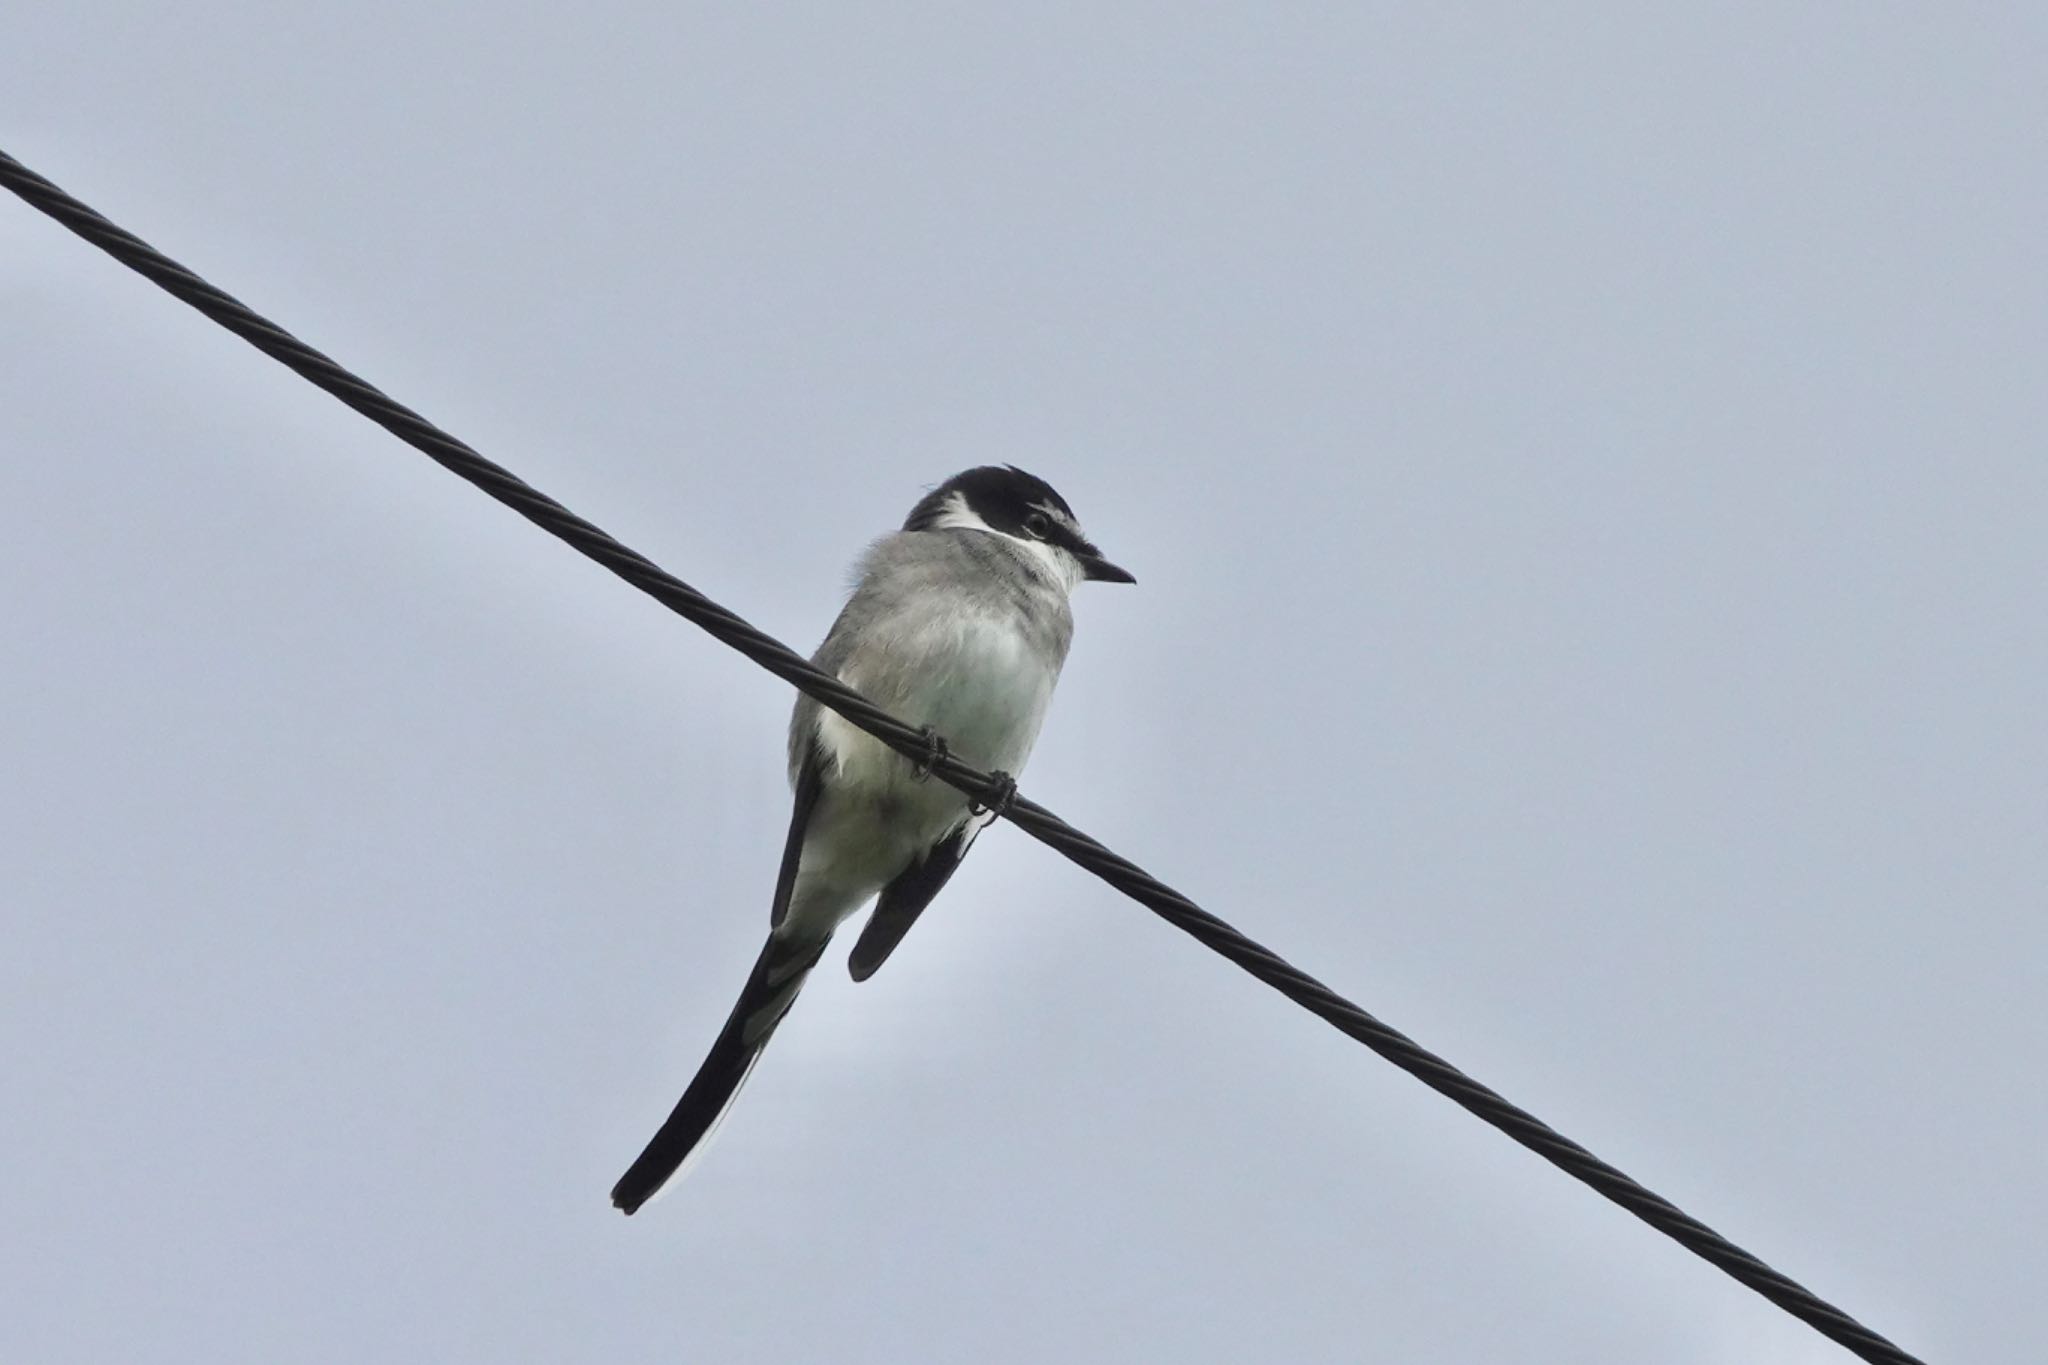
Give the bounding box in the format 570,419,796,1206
612,465,1137,1214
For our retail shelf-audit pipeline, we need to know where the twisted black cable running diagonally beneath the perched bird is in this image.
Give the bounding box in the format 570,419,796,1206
0,151,1921,1365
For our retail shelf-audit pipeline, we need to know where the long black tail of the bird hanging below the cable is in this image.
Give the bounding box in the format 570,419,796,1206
612,935,827,1214
